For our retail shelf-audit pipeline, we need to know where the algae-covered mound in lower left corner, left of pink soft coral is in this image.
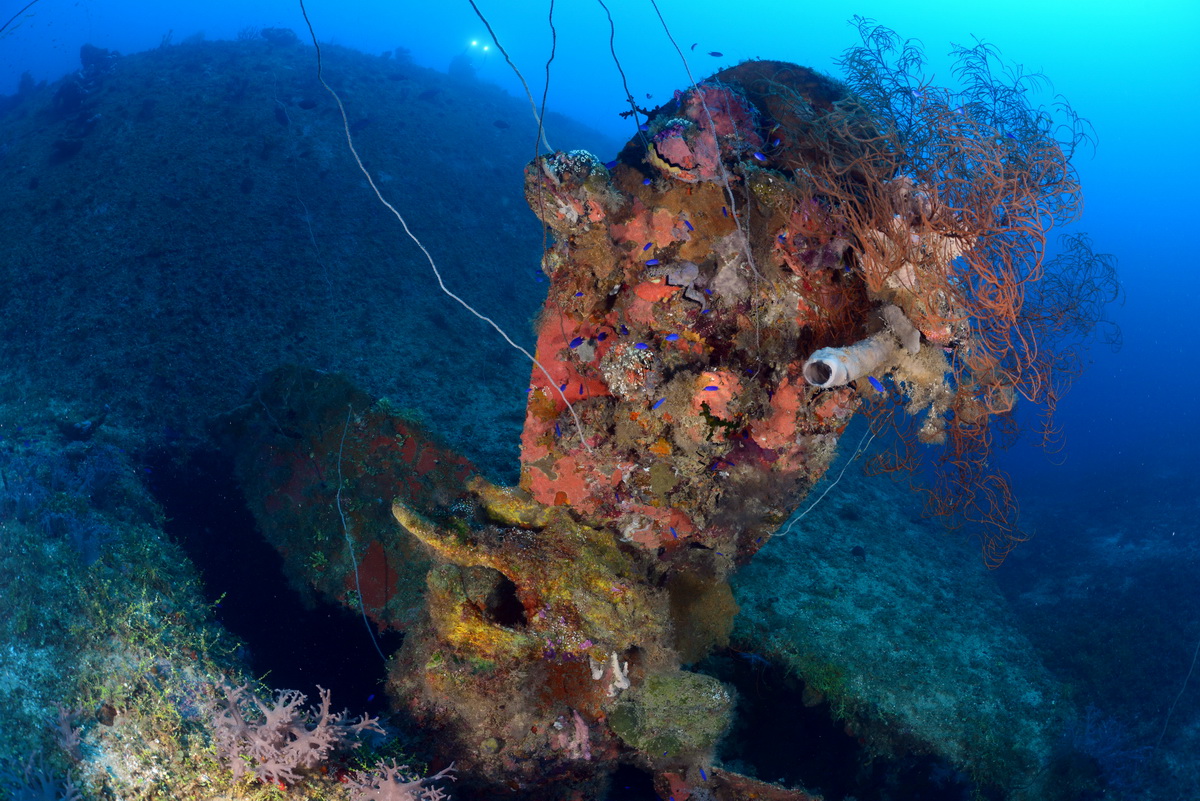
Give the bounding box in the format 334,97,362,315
0,434,241,799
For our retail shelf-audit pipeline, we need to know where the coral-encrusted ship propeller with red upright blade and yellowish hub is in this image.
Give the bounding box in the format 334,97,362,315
225,54,1099,799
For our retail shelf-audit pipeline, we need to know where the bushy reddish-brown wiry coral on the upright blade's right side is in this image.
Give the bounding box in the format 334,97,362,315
776,18,1118,565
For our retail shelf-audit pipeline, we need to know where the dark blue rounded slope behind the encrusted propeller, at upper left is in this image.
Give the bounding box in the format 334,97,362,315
0,37,613,475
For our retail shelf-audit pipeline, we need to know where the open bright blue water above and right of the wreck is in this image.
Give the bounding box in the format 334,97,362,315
7,0,1200,493
